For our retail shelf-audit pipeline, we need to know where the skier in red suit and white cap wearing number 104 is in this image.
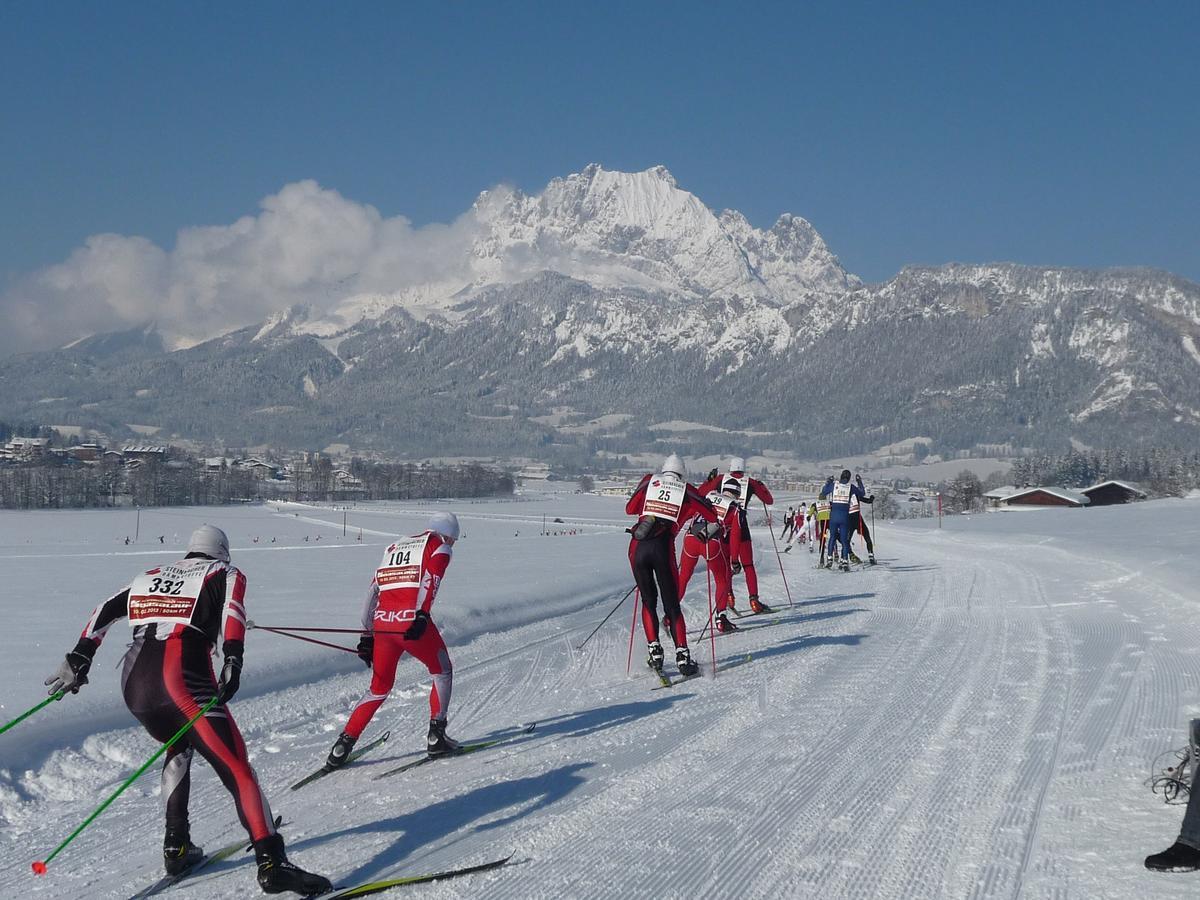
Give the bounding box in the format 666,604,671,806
326,512,460,768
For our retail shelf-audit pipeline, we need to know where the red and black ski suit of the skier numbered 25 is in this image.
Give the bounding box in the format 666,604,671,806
625,473,716,647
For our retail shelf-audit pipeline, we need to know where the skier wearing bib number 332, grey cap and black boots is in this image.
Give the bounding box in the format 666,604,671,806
46,524,331,895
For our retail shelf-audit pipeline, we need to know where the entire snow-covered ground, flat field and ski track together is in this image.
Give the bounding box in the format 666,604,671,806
0,494,1200,900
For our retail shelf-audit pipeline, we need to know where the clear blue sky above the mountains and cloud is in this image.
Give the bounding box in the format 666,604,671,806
0,2,1200,287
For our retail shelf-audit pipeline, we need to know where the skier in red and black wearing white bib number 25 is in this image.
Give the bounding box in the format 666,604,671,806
625,454,716,676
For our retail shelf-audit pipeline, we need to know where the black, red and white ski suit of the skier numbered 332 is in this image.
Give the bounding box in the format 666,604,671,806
74,553,275,841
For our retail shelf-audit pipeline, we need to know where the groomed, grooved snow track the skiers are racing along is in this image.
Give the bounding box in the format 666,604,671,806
0,503,1200,900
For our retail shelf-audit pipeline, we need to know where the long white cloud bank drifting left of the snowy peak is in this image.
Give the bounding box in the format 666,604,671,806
0,181,478,353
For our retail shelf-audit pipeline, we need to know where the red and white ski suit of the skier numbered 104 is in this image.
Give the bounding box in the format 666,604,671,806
346,532,454,738
